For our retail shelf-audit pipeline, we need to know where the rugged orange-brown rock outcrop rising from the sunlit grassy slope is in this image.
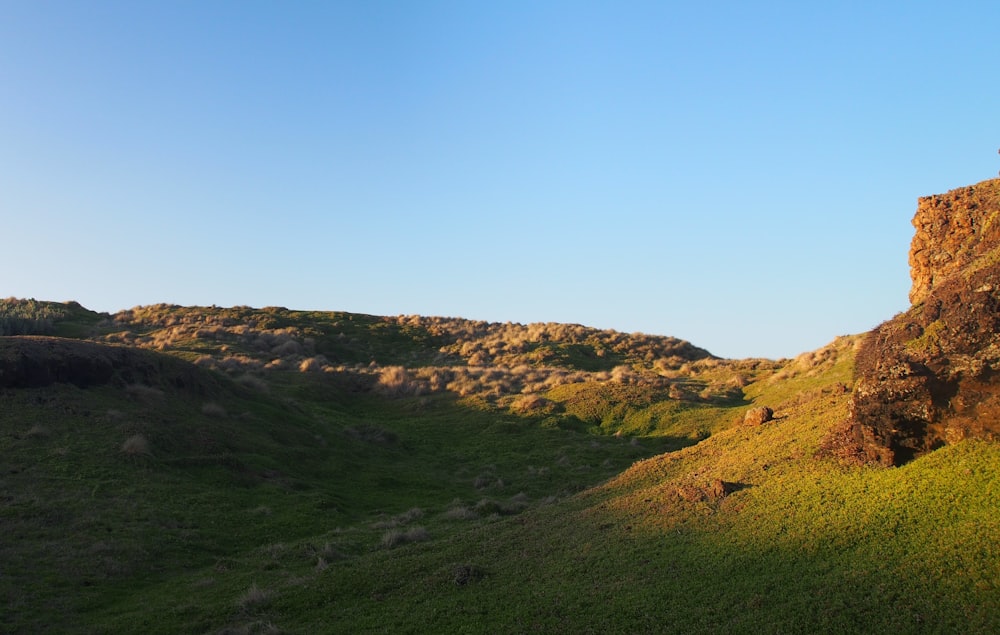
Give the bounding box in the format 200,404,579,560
827,179,1000,465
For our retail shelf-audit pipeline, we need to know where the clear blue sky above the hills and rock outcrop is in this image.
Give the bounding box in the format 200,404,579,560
0,0,1000,358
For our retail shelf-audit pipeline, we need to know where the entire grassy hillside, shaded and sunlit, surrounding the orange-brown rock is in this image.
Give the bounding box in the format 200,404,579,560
0,305,1000,633
